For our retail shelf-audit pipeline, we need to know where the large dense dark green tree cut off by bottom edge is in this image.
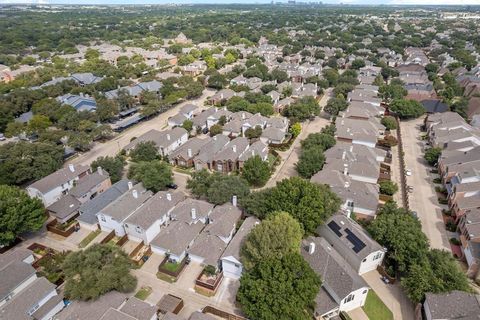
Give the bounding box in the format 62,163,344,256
237,253,321,320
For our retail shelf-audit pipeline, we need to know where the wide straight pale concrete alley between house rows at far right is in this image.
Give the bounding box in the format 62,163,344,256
400,118,451,252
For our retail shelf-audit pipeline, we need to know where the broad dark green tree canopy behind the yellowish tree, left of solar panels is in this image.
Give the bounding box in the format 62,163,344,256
241,177,340,233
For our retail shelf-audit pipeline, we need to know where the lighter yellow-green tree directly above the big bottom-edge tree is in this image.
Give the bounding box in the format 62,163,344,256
240,212,303,270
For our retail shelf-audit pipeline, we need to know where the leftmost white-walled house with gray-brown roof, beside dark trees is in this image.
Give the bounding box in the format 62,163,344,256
27,164,90,207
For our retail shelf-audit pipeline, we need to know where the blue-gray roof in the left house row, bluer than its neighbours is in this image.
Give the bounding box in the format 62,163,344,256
77,179,128,224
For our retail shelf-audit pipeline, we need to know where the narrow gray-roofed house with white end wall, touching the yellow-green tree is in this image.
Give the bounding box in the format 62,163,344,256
220,217,260,279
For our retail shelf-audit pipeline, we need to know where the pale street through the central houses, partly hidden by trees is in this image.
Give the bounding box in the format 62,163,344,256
264,89,331,188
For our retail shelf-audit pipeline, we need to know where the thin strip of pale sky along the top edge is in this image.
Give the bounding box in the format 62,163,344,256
0,0,480,5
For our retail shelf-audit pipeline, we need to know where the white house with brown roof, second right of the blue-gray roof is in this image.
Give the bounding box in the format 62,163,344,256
124,191,185,244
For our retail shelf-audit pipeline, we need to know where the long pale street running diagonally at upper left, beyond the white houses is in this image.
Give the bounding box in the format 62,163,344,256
65,89,216,165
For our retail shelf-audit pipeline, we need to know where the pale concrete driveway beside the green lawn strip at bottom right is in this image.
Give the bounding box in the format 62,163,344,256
362,270,415,320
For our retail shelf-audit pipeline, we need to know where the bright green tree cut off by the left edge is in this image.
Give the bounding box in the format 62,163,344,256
0,185,47,246
